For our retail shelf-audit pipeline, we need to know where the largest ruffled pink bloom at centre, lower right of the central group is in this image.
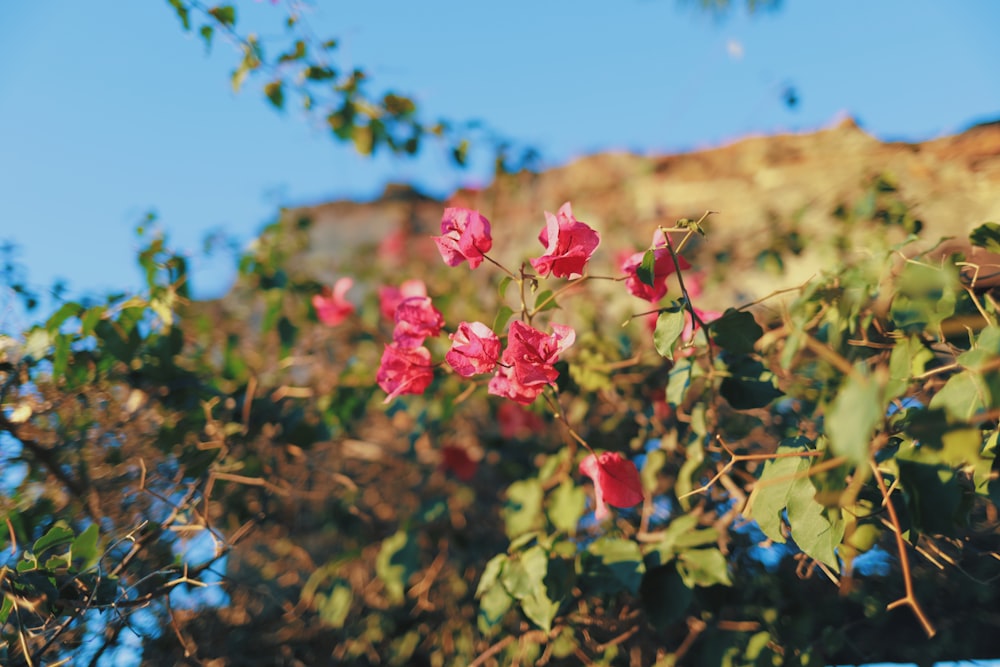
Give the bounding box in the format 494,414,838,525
488,320,576,405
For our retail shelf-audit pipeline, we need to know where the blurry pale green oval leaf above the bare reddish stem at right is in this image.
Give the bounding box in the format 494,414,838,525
823,376,885,467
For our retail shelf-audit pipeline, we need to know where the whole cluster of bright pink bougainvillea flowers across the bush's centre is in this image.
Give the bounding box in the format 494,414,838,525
364,202,719,520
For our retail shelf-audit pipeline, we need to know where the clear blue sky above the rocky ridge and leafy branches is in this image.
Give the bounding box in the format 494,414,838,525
0,0,1000,314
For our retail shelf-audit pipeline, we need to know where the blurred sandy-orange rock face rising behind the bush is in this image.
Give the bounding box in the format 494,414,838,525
289,119,1000,305
